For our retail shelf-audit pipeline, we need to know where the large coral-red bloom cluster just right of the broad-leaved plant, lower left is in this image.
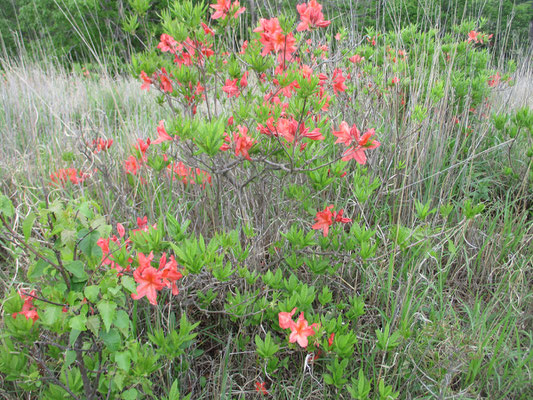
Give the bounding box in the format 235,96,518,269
131,252,183,305
